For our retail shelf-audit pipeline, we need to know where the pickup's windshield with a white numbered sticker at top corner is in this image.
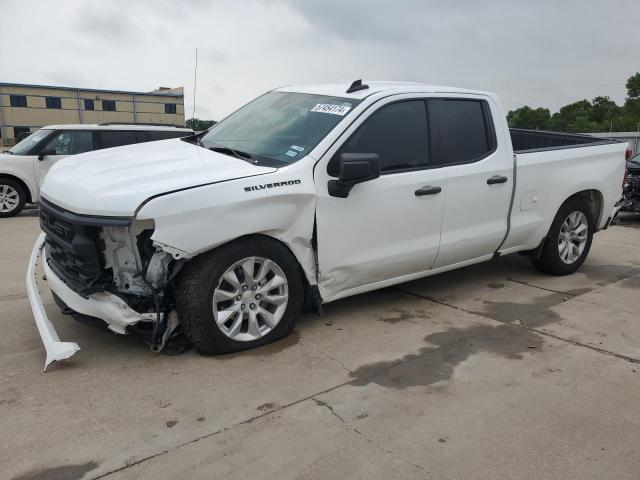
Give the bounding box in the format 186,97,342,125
201,92,360,166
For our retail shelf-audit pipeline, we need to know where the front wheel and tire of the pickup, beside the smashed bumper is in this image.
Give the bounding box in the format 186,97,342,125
176,236,304,354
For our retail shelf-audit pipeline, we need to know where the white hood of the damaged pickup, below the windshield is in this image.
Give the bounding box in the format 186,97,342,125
40,139,276,217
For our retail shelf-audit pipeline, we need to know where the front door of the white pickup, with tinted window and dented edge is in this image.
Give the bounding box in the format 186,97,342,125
315,97,446,301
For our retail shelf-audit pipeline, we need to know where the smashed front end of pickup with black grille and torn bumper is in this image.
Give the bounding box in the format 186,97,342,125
27,200,184,368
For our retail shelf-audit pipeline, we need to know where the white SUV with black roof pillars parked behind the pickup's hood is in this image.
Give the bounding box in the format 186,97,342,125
0,124,193,218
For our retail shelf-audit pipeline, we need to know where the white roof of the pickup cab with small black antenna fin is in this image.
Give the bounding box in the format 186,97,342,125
276,80,491,99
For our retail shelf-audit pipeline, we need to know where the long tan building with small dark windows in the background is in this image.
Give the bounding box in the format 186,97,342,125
0,82,185,146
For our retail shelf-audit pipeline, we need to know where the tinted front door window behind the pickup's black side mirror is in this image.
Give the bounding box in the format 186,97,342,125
336,100,429,176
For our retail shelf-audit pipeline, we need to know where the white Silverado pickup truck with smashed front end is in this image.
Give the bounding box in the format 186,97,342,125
27,81,626,368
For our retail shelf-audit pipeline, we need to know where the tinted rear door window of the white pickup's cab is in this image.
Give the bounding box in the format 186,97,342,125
429,99,496,165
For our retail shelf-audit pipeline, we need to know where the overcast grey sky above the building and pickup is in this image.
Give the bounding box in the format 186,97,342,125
0,0,640,119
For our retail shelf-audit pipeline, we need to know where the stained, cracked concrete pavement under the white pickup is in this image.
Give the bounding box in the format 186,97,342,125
0,212,640,480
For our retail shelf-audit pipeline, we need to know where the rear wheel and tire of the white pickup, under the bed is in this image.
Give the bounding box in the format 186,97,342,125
533,197,595,275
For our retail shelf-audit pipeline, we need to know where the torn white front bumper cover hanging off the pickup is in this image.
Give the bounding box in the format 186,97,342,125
26,233,156,370
